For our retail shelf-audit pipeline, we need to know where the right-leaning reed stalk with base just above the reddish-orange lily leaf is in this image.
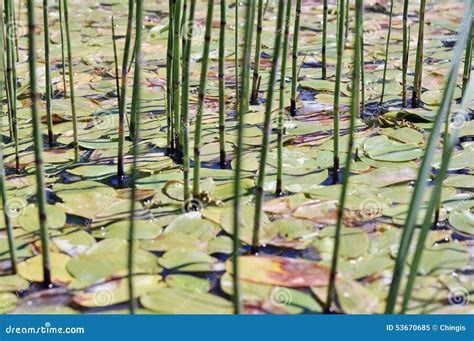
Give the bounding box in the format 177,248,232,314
252,0,285,253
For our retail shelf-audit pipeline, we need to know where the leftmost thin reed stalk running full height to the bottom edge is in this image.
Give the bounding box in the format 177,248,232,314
128,0,143,314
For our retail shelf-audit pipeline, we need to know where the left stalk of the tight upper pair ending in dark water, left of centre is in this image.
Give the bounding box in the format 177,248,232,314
166,0,174,152
